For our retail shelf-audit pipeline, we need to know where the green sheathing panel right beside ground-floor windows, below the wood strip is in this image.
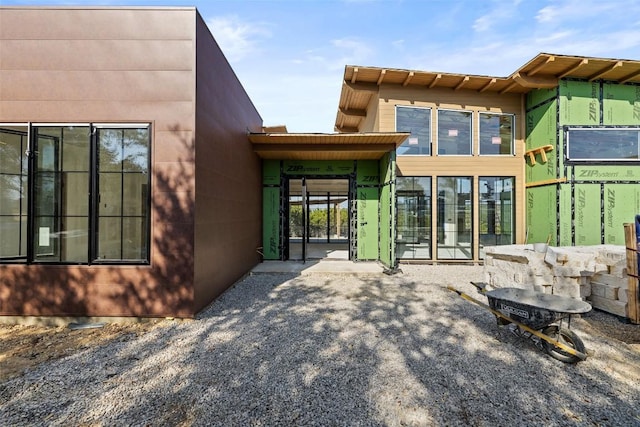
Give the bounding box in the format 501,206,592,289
527,185,557,245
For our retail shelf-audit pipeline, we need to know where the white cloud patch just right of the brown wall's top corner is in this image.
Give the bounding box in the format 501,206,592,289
207,16,271,62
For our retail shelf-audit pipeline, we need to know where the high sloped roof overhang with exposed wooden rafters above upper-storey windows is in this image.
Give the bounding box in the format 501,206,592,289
335,53,640,132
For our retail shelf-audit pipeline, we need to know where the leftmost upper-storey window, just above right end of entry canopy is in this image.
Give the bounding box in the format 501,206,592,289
396,106,431,156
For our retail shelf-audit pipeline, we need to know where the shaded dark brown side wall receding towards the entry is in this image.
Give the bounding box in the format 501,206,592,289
194,15,262,311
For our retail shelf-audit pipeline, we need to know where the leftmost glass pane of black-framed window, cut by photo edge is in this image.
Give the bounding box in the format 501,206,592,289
0,126,28,261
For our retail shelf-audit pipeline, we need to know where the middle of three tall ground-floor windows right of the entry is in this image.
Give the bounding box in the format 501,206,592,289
437,177,473,259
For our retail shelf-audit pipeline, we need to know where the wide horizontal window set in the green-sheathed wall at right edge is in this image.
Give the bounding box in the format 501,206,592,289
565,127,640,162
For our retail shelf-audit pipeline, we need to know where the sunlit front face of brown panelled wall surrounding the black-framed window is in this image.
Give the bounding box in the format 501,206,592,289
0,8,200,317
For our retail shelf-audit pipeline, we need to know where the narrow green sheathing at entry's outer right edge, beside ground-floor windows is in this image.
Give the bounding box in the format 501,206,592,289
379,153,396,268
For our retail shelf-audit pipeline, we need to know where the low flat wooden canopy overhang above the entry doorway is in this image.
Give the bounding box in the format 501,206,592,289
249,132,409,160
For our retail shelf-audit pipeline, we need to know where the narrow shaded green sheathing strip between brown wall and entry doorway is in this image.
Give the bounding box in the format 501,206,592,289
262,160,281,260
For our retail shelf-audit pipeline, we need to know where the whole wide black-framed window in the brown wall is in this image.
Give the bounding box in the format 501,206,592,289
0,125,150,264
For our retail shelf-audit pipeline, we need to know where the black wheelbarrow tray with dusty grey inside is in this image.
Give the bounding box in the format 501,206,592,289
484,288,591,330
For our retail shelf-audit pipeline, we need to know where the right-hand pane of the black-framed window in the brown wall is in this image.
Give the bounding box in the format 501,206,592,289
97,128,149,261
